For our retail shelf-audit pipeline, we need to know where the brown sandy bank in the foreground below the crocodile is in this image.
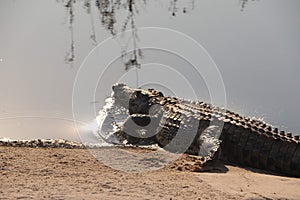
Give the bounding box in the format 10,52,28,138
0,147,300,199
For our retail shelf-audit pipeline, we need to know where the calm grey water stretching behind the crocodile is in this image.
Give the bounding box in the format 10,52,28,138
0,0,300,141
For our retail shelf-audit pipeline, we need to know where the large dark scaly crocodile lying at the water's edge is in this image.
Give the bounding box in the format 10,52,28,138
101,83,300,177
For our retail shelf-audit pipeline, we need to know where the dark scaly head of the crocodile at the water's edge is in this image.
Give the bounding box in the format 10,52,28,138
112,83,163,145
